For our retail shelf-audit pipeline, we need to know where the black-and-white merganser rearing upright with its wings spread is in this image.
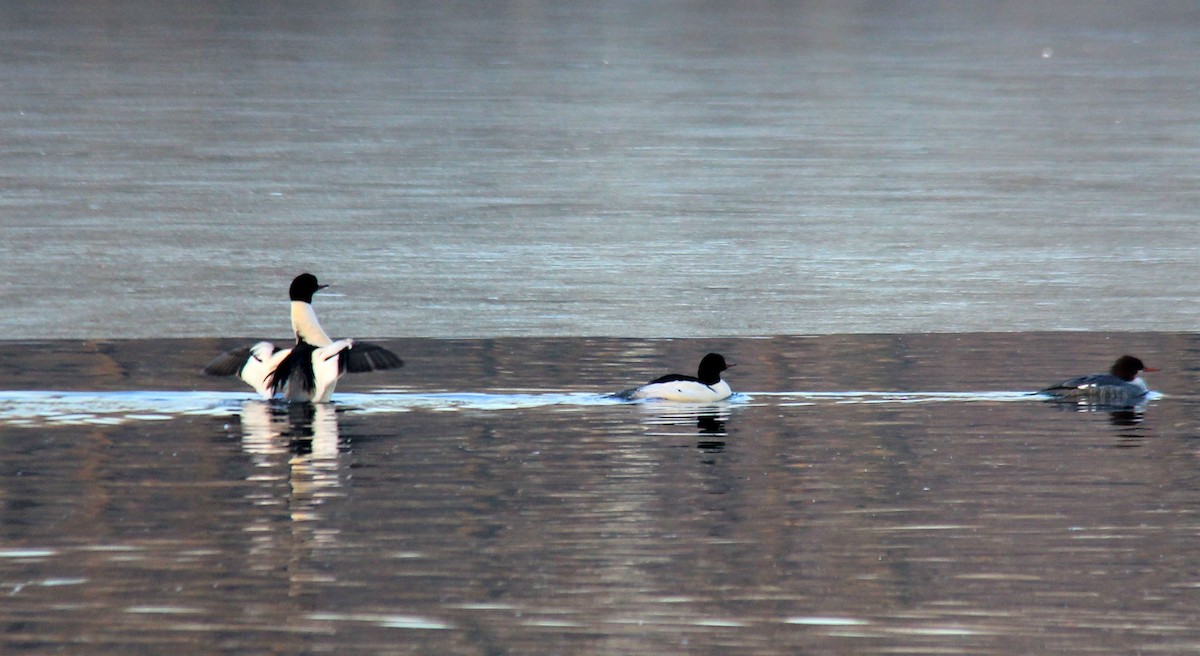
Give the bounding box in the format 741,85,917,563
204,273,404,403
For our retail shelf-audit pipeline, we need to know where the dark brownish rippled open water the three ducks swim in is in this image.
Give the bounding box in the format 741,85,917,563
0,333,1200,654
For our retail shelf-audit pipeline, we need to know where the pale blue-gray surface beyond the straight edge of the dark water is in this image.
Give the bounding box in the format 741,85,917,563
0,1,1200,338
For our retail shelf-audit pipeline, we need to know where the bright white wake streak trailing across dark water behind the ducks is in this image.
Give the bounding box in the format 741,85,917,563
0,390,1070,426
